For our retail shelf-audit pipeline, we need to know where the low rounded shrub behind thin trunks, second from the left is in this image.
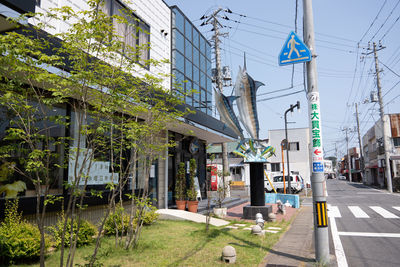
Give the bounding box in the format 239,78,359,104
49,217,96,247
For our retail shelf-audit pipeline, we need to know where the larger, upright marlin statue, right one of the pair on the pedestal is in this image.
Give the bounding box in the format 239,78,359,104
234,55,264,139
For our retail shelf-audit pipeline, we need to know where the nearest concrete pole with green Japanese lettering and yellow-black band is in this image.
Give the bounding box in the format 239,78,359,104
303,0,329,265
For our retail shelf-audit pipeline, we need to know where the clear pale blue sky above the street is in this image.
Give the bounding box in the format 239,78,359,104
165,0,400,158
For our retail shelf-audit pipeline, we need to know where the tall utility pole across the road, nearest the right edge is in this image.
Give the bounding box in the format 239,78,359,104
374,42,393,193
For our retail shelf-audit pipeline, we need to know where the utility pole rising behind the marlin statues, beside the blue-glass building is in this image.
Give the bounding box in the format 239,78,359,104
206,8,230,197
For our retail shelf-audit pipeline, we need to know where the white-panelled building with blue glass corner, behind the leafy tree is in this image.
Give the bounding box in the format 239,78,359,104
0,0,237,215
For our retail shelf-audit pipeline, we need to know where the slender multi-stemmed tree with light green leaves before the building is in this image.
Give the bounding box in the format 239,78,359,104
0,0,188,266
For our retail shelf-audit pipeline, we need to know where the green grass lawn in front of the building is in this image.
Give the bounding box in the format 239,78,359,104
14,220,289,267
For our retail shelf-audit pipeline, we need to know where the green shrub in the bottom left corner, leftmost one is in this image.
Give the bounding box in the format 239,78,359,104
0,200,44,263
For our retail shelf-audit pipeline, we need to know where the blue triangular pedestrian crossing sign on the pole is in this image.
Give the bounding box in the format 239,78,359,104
278,31,311,66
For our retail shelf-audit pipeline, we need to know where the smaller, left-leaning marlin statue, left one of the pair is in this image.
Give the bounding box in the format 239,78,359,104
214,89,244,139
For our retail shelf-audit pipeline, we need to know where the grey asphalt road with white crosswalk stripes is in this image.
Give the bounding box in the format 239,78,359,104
327,179,400,267
